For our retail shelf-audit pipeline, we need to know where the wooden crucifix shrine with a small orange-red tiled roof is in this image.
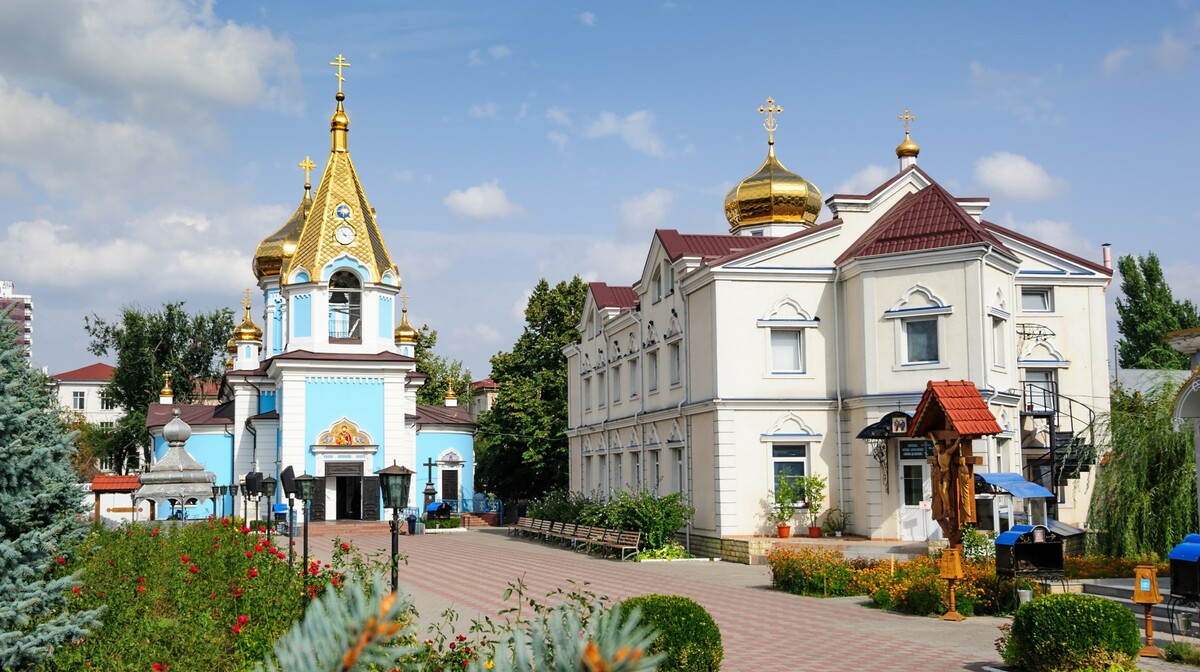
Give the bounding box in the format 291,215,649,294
908,380,1002,620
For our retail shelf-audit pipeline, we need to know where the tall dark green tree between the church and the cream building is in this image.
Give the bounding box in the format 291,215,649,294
475,276,587,499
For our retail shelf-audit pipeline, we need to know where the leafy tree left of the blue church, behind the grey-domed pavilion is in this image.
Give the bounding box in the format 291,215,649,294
84,301,233,473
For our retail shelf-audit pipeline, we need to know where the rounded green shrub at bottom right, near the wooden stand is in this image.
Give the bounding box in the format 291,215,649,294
1001,593,1141,672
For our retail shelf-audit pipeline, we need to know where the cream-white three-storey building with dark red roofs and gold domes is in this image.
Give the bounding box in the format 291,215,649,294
564,106,1112,540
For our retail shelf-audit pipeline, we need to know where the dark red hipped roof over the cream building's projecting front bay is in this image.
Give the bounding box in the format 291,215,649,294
835,182,1015,264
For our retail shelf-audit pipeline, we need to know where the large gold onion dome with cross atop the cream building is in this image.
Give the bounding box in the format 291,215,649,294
725,98,821,230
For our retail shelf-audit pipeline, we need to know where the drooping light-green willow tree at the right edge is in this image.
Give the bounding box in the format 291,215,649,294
1090,379,1196,557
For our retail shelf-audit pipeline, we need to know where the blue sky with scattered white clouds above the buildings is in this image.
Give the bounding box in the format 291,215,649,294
0,0,1200,379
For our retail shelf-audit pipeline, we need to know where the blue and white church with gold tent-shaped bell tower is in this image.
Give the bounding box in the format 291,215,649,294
146,65,475,521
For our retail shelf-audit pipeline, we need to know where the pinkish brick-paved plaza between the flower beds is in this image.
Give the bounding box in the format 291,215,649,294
298,523,1176,672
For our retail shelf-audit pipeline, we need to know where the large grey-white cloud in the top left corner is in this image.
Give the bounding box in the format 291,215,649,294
0,0,302,119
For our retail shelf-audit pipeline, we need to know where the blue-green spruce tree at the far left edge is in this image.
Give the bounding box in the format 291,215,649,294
0,316,98,670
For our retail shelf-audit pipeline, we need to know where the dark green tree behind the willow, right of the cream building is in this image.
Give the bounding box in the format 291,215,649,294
1117,252,1200,368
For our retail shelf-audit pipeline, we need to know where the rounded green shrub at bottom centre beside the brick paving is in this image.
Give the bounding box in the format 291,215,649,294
620,595,725,672
